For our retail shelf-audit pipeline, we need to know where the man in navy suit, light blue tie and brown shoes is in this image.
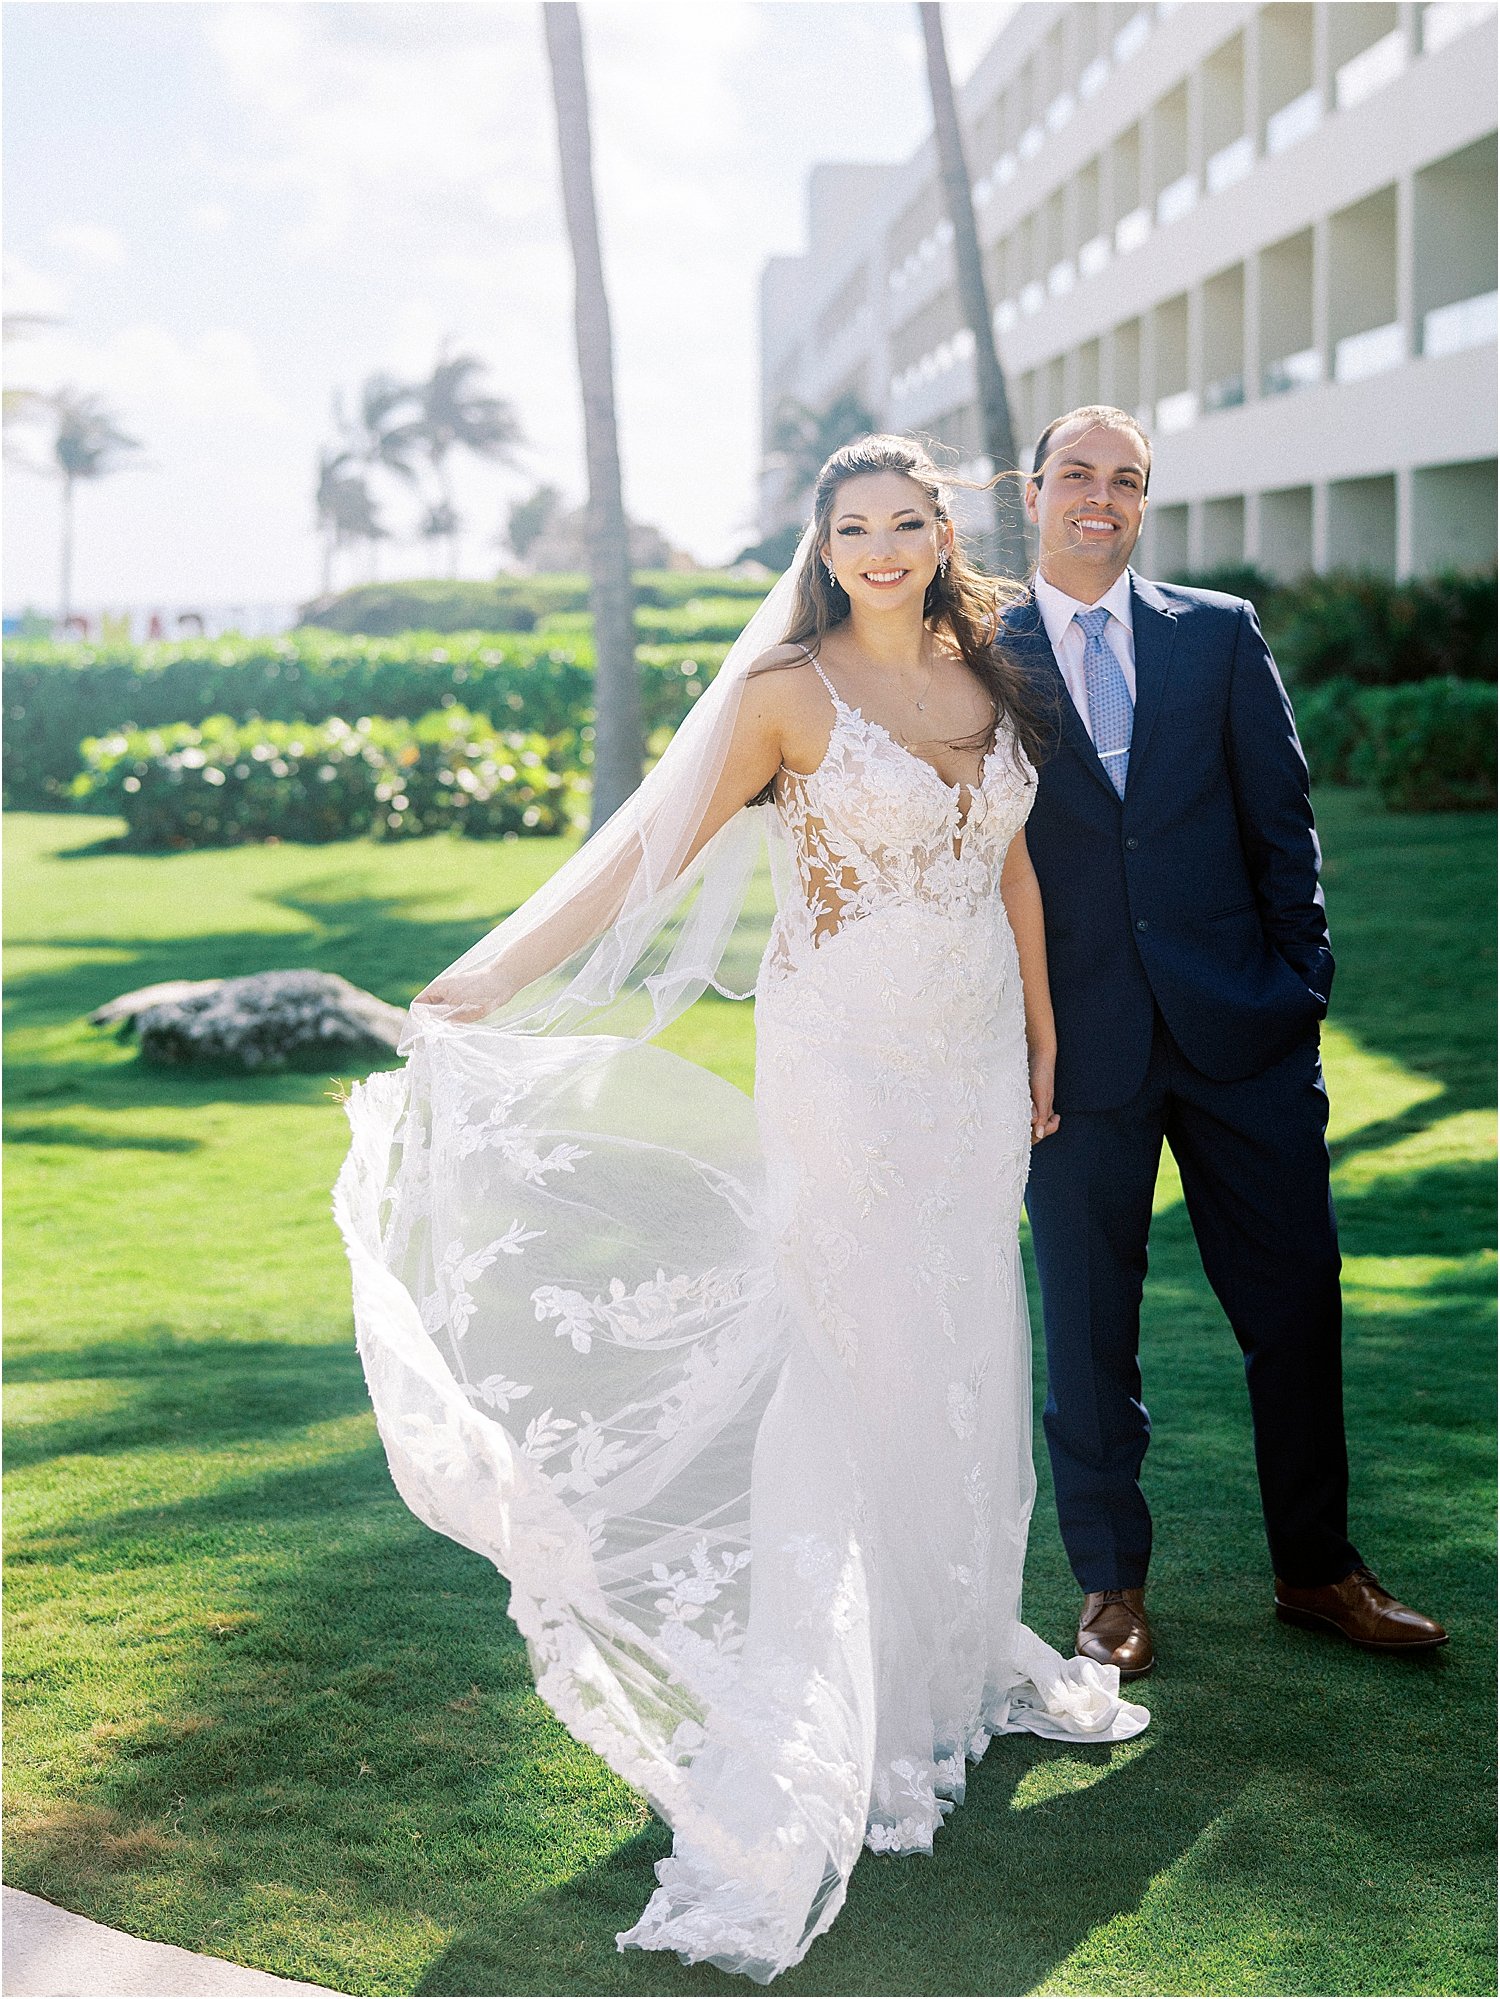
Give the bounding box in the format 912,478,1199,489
1004,408,1446,1679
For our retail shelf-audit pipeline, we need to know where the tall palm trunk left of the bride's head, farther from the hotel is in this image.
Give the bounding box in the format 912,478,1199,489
542,0,644,832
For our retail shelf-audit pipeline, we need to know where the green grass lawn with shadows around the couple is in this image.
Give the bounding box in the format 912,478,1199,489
6,794,1494,1995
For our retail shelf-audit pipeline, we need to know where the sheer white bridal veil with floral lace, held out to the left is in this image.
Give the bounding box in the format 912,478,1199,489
336,530,874,1979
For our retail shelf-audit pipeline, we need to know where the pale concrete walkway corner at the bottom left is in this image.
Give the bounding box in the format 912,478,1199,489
0,1887,350,1999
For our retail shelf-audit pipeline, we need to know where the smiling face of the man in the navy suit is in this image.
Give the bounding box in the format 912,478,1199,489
1026,422,1148,604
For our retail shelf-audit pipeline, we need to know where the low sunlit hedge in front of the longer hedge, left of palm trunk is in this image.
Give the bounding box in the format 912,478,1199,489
74,708,588,850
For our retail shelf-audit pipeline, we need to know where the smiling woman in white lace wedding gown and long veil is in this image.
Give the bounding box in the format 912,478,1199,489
336,436,1146,1981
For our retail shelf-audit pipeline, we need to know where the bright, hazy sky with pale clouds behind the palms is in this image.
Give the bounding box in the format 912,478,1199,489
4,0,1012,612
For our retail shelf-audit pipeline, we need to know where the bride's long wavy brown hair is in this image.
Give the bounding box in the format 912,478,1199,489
784,434,1050,762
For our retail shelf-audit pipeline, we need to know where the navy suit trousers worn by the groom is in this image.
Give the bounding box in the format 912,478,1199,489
1026,1013,1360,1589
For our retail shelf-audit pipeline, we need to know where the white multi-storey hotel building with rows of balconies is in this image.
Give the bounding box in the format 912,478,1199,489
762,0,1496,576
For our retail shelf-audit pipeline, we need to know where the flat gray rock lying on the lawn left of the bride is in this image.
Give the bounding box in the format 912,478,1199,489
90,972,406,1069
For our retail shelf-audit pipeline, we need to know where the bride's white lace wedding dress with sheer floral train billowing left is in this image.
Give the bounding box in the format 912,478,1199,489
338,655,1146,1981
